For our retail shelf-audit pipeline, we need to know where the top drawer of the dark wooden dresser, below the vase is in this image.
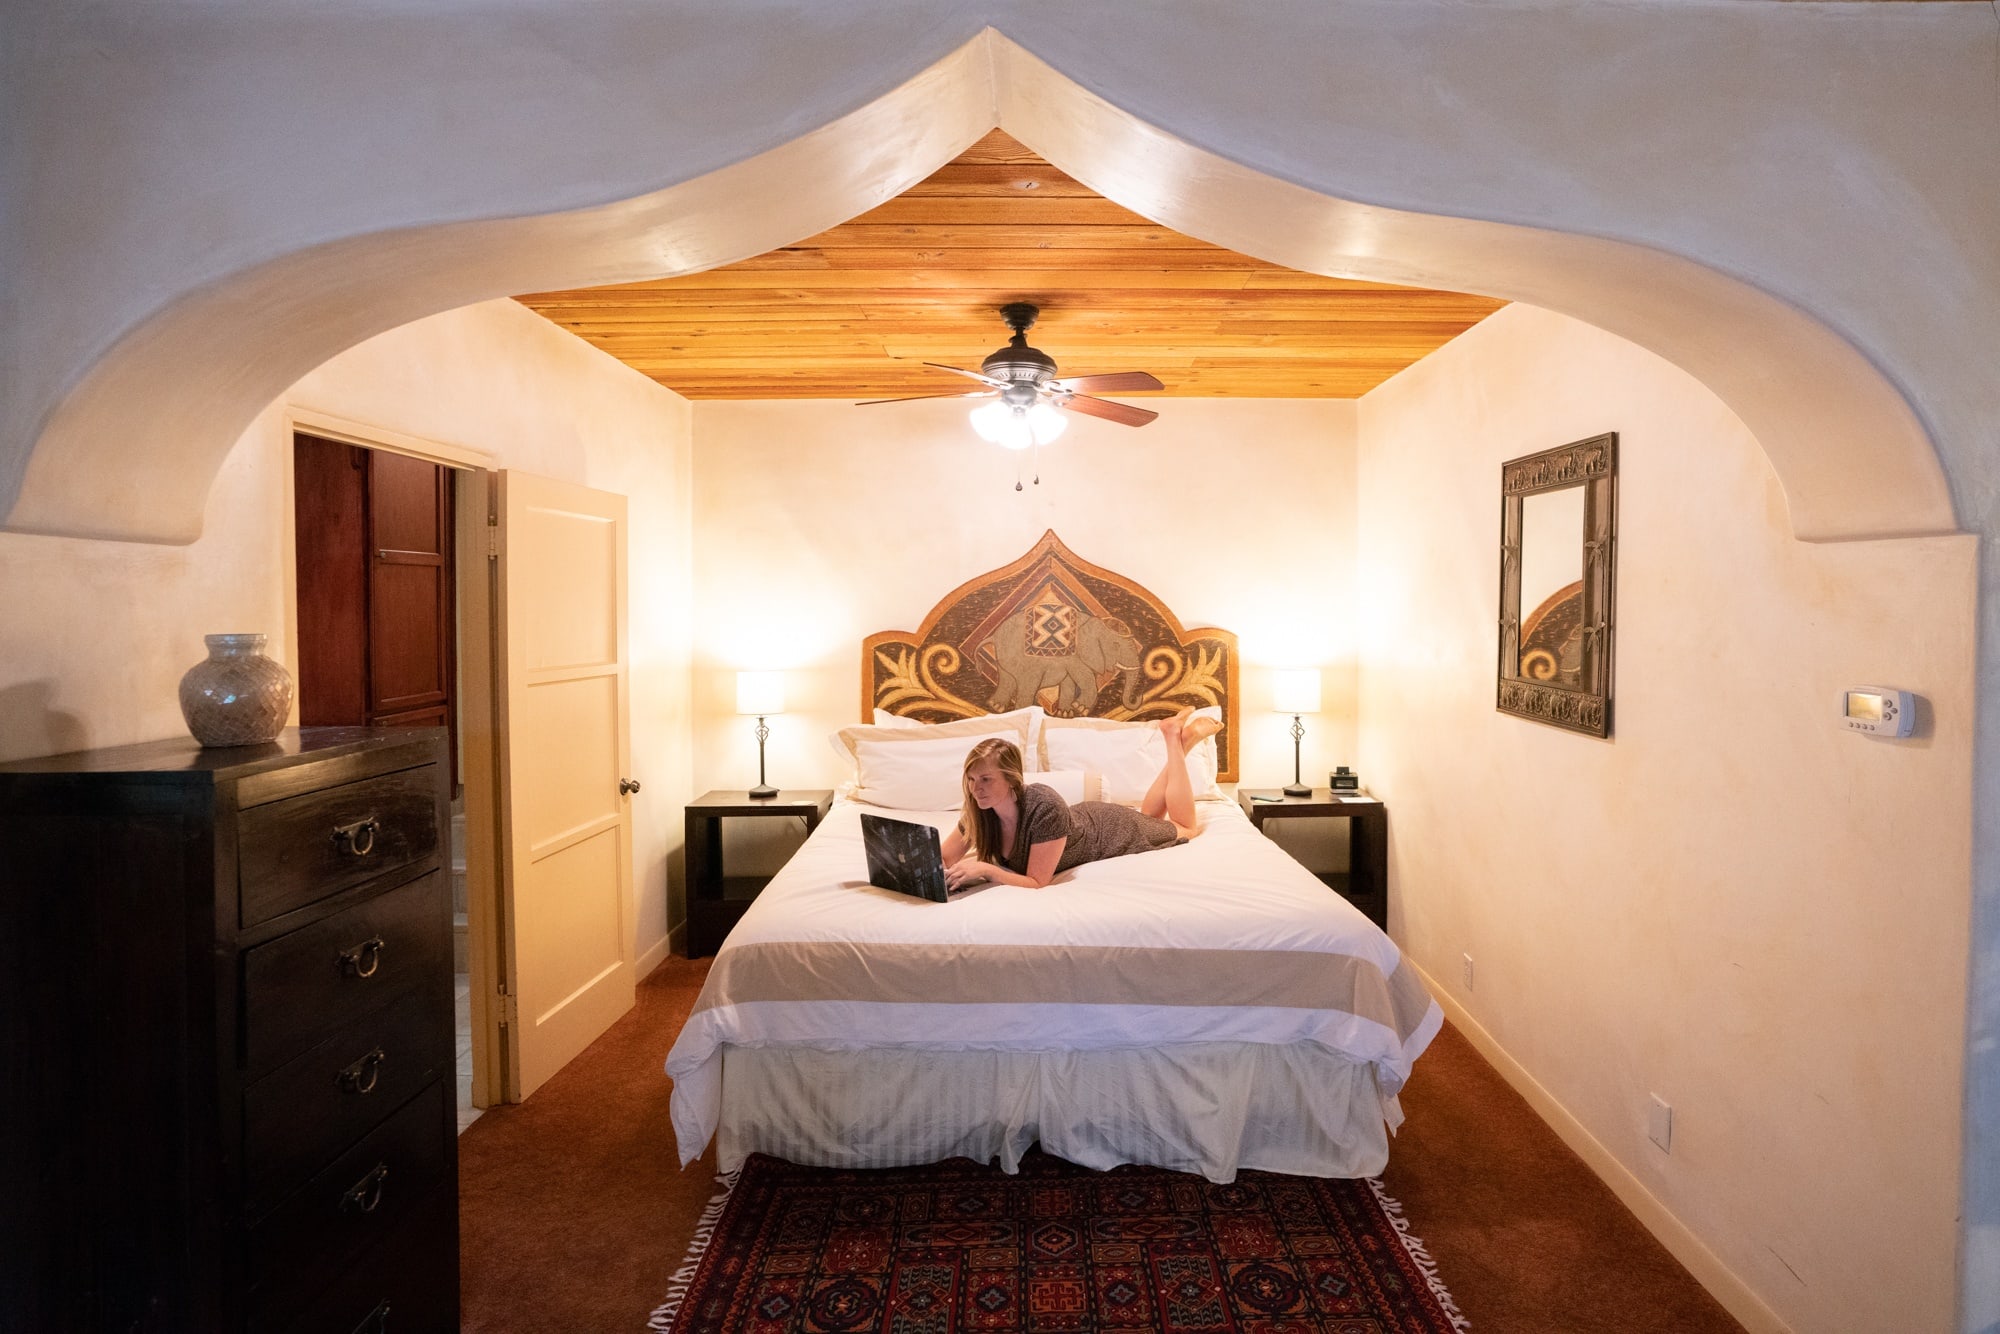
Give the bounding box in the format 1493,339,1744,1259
236,764,438,926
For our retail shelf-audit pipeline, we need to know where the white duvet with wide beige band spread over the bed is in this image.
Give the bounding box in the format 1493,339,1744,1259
666,800,1442,1164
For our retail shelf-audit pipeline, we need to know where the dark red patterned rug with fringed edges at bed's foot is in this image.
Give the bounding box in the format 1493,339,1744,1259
648,1152,1468,1334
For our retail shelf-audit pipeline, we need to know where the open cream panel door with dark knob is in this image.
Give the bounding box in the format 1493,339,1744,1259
494,472,634,1102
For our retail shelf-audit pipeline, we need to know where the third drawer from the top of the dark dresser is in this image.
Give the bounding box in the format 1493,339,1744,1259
244,984,454,1216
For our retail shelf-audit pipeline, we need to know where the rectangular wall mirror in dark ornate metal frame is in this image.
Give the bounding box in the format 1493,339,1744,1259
1494,432,1618,736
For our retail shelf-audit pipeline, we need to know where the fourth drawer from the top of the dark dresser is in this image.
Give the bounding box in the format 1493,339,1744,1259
248,1080,454,1328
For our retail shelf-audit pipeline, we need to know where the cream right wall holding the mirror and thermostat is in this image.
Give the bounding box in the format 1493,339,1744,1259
1358,306,1976,1330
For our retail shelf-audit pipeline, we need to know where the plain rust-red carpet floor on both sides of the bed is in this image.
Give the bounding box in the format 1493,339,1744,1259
458,958,1742,1334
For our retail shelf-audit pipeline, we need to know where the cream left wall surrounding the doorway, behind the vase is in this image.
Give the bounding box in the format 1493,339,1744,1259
0,300,692,972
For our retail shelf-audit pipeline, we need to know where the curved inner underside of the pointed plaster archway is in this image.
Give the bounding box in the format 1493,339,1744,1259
0,28,1954,542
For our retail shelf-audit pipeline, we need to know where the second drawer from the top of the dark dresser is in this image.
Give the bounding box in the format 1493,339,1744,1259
244,870,452,1072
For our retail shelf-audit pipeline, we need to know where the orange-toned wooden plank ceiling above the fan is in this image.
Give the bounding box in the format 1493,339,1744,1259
520,130,1504,400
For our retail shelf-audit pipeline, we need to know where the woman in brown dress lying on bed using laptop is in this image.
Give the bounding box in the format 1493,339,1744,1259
944,710,1222,890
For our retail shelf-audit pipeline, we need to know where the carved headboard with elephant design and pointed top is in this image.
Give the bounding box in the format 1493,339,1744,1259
862,530,1236,782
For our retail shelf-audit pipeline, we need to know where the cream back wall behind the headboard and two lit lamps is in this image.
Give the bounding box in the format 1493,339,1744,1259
694,398,1354,808
